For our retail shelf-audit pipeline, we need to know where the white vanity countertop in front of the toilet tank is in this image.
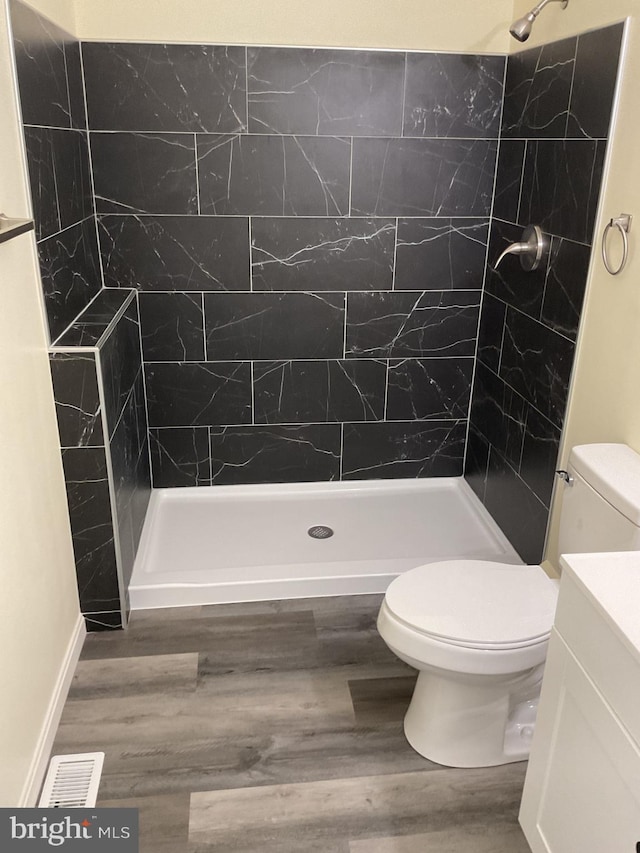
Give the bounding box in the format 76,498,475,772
560,551,640,660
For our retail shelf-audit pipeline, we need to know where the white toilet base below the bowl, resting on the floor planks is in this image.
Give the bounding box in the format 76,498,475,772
404,666,543,767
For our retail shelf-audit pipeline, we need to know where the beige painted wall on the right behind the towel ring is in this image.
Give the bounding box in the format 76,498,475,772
508,6,640,566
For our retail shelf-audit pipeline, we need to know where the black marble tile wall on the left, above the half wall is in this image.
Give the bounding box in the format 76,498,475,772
10,0,102,341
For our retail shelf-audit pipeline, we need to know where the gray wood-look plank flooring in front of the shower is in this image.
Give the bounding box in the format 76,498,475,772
54,596,529,853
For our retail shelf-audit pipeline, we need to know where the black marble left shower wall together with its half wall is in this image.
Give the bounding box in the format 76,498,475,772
11,3,150,630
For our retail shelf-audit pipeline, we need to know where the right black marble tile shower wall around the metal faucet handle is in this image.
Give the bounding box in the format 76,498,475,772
465,24,623,563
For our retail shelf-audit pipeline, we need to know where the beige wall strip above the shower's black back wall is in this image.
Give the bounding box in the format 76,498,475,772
69,0,512,52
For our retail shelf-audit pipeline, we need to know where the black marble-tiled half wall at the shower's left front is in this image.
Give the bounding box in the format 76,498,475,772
50,290,151,630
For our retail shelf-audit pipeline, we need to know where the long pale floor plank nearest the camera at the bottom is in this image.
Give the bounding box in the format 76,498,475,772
189,764,524,851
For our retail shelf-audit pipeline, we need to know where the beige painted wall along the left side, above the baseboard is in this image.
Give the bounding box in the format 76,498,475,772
0,3,79,806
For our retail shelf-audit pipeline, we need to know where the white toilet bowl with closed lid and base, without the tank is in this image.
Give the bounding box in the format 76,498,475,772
378,560,557,767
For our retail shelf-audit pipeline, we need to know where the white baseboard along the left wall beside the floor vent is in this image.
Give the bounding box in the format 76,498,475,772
18,614,87,808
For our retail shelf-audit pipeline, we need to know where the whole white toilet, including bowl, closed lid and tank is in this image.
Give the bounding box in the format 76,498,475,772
378,444,640,767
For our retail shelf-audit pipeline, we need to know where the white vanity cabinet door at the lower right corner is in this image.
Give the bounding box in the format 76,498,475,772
520,634,640,853
